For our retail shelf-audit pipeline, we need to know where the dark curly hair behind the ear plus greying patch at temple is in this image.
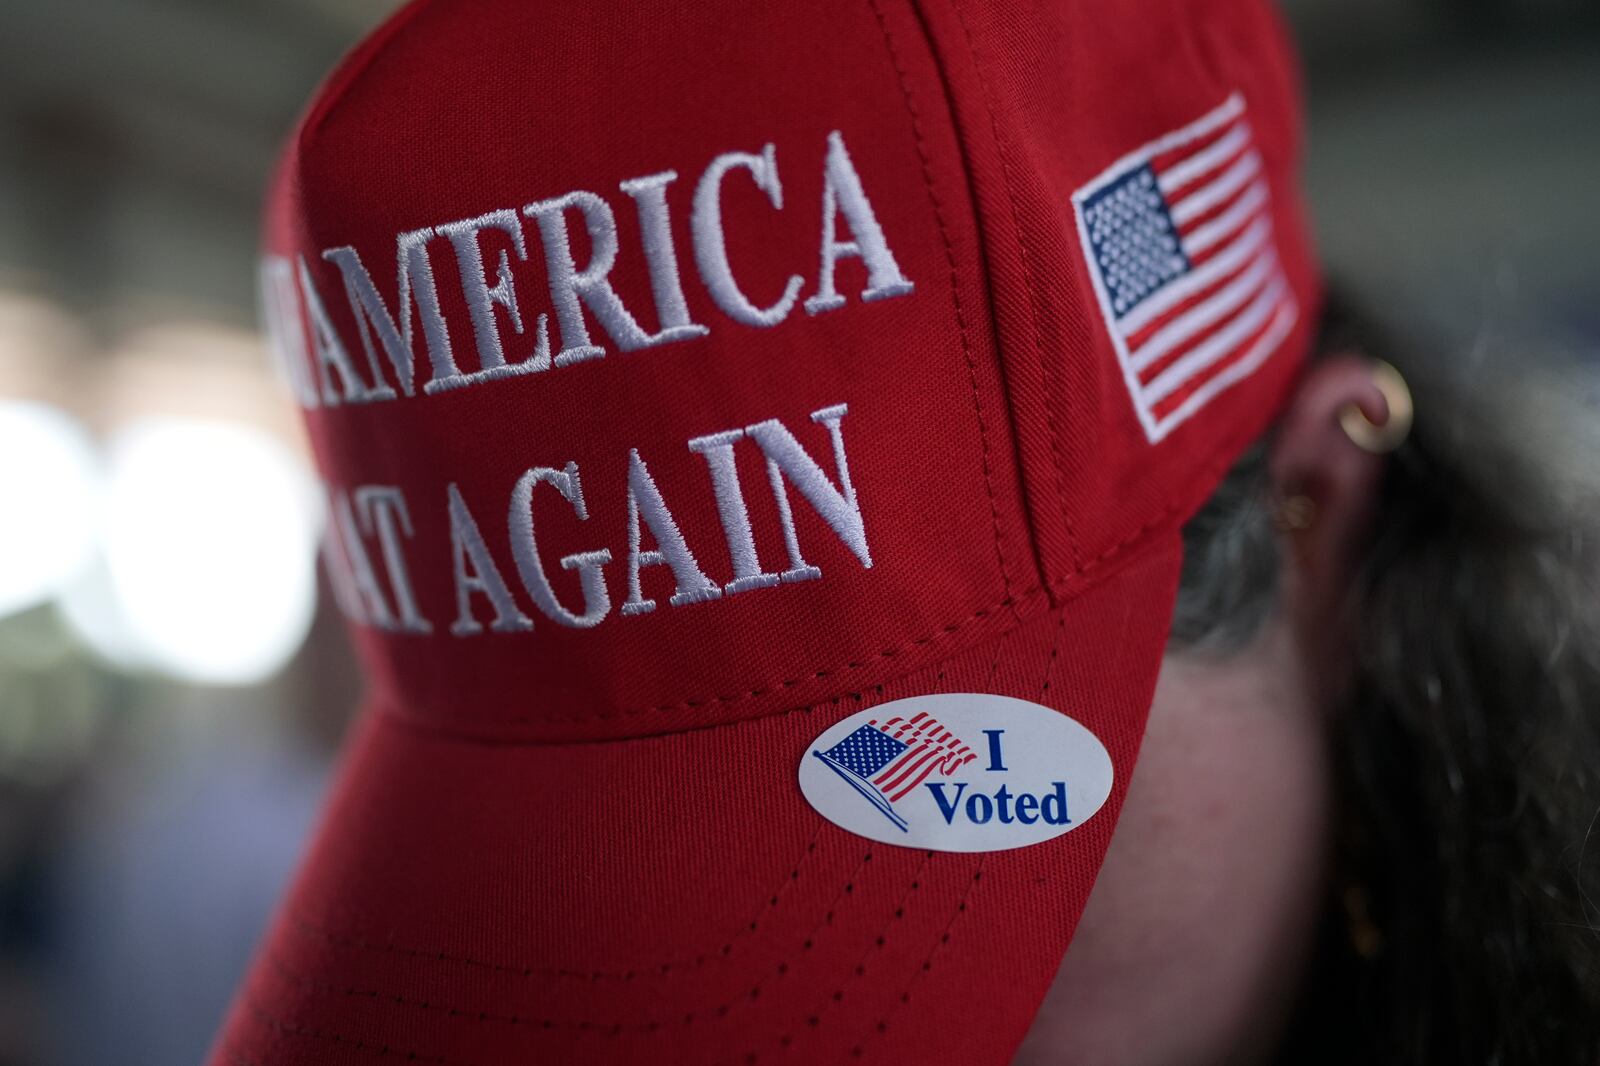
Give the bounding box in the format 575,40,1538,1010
1173,286,1600,1066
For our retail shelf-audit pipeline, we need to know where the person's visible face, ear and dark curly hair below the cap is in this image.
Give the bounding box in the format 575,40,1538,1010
1018,298,1600,1066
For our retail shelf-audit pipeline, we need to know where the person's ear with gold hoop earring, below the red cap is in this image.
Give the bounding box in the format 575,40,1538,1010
1269,355,1410,632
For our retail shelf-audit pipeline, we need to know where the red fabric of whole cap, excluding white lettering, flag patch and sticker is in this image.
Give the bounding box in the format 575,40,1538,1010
214,0,1315,1066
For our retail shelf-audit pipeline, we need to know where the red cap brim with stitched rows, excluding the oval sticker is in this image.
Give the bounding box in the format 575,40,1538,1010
213,535,1181,1066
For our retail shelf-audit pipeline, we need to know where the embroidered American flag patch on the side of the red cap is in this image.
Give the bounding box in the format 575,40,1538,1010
1072,93,1299,443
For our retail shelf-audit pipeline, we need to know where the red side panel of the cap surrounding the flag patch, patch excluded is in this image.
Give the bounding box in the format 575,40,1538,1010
920,0,1318,591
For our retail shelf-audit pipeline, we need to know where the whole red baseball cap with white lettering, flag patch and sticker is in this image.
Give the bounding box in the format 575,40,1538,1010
213,0,1318,1066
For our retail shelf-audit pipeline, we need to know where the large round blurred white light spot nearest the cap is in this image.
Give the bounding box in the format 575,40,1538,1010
91,418,318,685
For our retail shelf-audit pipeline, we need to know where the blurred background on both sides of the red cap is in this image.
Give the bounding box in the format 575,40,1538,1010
0,0,1600,1066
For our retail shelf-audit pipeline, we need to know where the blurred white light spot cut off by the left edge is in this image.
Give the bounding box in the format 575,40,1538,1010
0,400,98,615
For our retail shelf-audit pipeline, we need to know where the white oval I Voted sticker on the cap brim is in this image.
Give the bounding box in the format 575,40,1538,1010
800,693,1114,852
